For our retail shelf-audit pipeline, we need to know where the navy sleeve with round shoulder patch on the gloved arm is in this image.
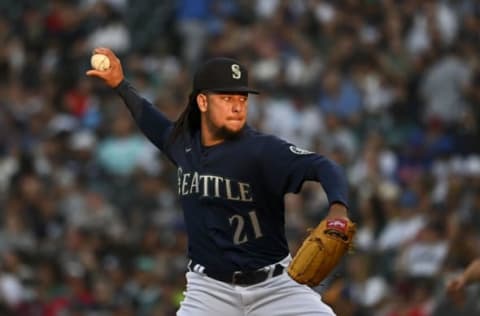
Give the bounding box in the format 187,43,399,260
260,136,348,207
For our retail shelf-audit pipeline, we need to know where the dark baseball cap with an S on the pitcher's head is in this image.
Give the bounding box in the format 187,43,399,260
193,57,259,94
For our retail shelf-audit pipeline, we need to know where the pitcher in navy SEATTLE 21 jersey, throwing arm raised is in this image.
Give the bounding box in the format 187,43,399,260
87,48,355,316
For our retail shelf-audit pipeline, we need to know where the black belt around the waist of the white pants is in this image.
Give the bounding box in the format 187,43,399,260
188,260,284,285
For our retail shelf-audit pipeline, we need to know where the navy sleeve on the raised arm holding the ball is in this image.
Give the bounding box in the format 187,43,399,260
115,80,173,156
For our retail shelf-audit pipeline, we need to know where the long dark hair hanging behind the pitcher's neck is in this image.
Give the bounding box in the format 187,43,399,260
171,91,200,142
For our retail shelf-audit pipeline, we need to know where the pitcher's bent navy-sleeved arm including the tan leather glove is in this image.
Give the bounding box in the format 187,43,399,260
263,138,355,286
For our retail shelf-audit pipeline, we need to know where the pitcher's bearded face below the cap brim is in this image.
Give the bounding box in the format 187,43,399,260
203,92,248,137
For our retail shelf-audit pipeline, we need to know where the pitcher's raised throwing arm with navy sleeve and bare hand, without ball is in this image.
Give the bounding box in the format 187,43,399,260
87,48,173,150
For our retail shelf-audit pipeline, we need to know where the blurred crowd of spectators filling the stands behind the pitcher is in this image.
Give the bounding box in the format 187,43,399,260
0,0,480,316
